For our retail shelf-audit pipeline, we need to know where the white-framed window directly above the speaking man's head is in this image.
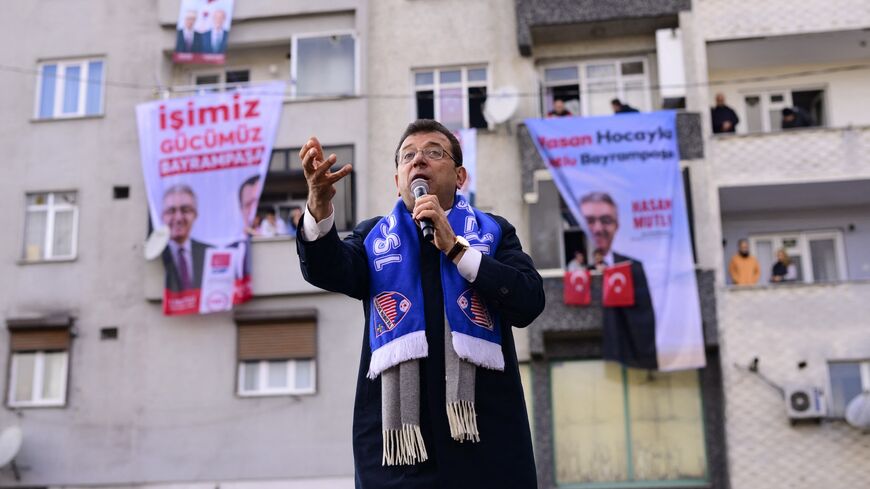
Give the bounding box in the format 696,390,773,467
414,67,488,131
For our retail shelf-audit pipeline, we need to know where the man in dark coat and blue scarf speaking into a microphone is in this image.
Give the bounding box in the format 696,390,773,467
296,120,544,489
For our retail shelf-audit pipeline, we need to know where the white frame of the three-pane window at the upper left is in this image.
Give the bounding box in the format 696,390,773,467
33,57,107,121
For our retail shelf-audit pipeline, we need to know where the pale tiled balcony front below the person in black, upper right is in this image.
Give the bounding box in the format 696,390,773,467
708,126,870,187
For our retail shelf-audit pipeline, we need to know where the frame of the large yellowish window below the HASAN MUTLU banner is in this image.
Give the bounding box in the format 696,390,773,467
547,357,711,489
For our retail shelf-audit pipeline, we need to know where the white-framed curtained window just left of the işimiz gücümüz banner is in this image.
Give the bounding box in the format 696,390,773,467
23,192,79,261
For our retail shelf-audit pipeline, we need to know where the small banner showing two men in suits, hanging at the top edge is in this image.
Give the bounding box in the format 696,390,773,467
172,0,234,65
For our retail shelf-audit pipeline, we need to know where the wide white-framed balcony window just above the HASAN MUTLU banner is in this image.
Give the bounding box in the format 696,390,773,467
543,58,652,116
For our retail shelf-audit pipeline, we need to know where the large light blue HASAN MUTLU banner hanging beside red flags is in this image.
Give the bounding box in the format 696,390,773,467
526,111,705,370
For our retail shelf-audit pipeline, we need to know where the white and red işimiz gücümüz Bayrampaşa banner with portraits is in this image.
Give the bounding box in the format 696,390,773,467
136,82,284,315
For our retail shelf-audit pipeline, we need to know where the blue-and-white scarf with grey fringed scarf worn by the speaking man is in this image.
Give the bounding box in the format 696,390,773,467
365,195,504,465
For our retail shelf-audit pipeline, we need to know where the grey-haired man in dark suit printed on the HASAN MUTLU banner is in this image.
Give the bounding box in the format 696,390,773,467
580,192,658,369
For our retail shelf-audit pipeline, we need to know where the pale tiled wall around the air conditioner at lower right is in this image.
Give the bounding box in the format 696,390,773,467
718,282,870,489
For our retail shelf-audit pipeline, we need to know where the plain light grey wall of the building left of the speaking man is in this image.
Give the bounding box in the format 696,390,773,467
0,0,368,488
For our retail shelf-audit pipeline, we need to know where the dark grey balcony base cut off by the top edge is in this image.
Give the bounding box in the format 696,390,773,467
516,0,692,56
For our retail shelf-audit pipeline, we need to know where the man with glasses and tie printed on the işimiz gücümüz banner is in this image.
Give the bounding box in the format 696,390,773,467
162,184,209,292
